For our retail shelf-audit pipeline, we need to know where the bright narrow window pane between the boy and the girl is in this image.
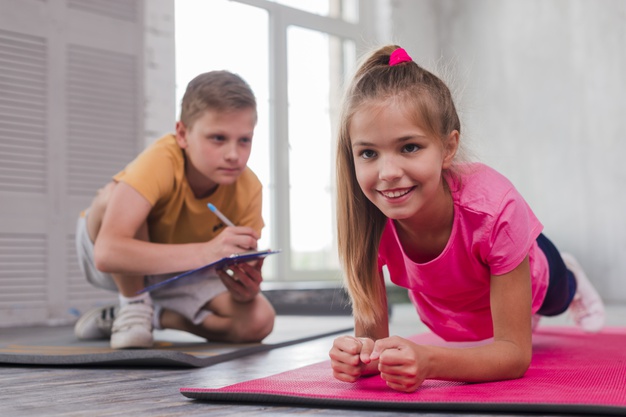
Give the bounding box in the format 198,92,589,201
287,26,353,270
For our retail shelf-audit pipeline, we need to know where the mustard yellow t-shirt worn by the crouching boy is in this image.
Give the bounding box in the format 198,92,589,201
113,134,264,243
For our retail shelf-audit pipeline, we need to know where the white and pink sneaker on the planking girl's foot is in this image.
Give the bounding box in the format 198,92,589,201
561,253,606,333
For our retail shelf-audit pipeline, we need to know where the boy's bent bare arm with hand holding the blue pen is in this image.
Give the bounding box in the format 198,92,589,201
94,182,257,275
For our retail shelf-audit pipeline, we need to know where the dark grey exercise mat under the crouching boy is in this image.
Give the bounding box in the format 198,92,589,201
0,316,352,367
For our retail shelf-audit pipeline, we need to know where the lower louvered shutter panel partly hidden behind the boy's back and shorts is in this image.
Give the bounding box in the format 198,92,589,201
66,235,117,304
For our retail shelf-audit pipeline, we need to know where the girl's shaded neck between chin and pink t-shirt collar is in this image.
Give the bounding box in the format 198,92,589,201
395,180,454,263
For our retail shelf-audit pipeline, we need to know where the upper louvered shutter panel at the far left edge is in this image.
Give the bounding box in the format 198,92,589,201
0,30,47,193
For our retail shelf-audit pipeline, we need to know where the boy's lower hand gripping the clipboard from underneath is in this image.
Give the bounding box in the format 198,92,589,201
217,258,264,303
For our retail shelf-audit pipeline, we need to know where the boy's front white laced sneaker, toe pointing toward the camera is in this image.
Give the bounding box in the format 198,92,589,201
111,301,154,349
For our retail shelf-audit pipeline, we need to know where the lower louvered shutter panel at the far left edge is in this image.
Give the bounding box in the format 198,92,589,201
0,233,47,311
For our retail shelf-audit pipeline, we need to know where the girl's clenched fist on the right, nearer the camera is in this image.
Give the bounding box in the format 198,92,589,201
370,336,425,392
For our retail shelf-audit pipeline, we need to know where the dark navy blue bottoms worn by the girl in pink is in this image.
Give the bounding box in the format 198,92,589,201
537,233,576,316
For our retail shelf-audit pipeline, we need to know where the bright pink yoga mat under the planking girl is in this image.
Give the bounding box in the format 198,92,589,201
181,327,626,415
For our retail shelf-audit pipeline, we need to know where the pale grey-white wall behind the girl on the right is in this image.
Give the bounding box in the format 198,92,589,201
386,0,626,302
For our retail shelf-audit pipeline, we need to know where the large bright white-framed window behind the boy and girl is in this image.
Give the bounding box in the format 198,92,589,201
175,0,363,281
